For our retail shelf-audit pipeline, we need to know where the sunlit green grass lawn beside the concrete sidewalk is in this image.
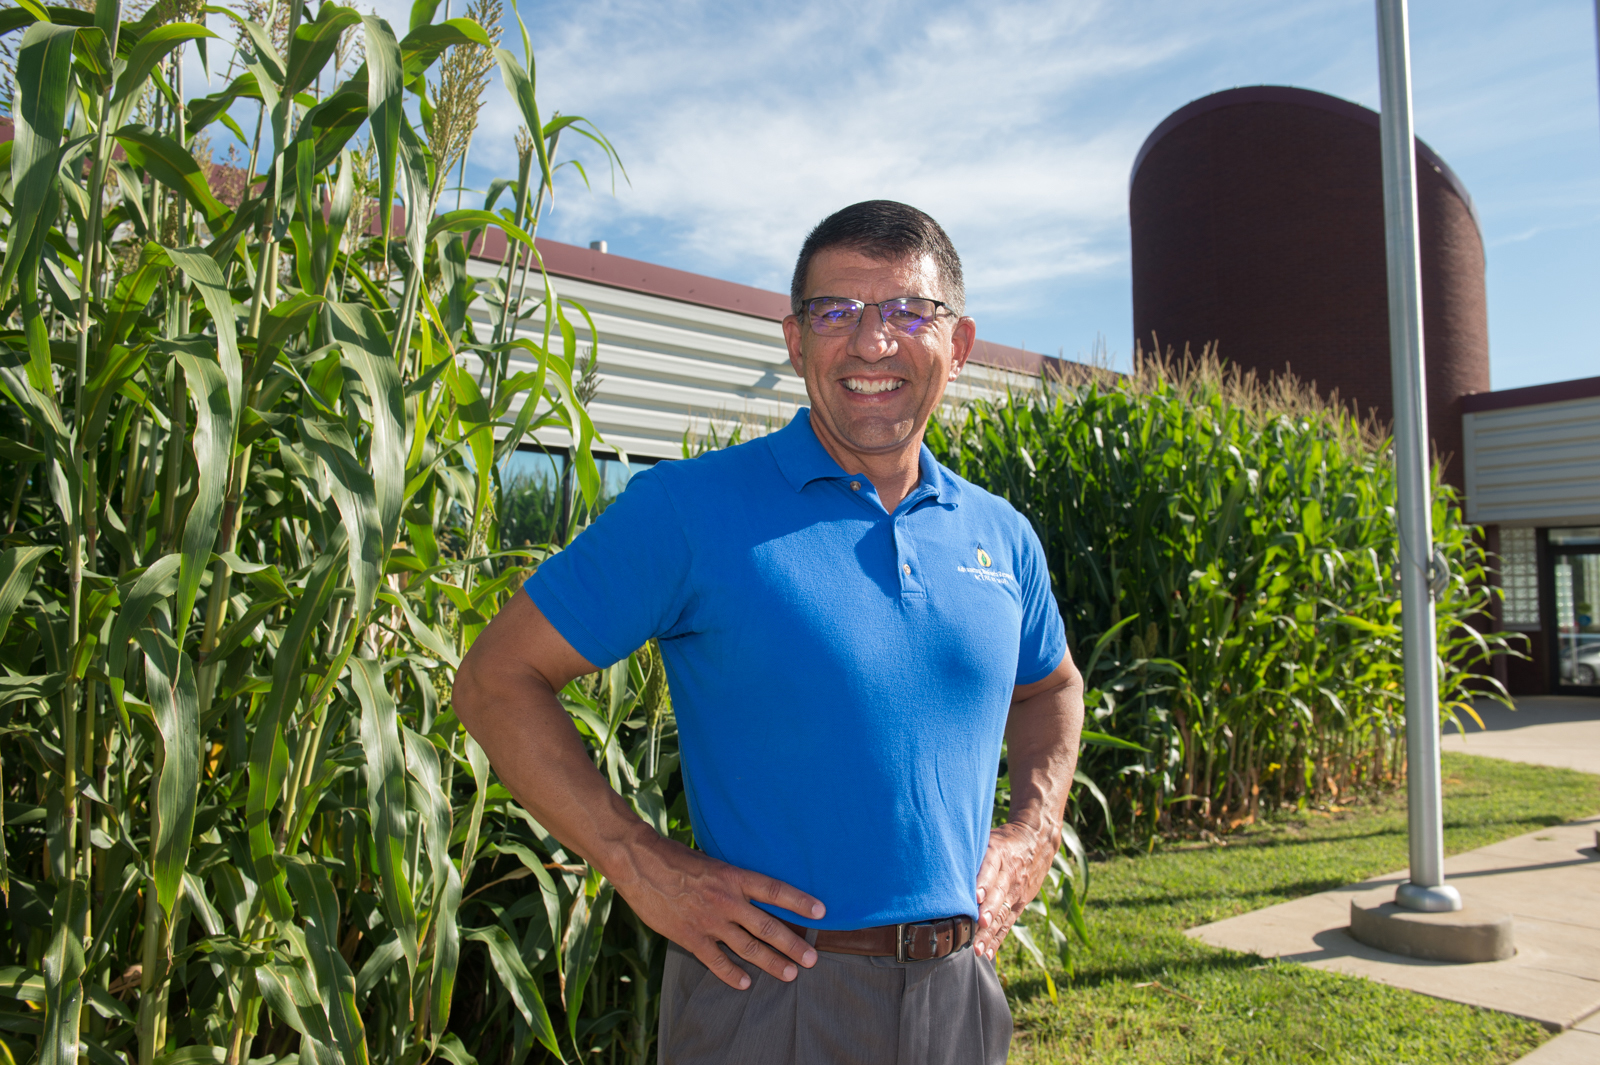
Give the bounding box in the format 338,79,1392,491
1000,753,1600,1065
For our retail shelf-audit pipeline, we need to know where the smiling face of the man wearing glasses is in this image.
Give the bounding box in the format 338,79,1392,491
784,248,976,459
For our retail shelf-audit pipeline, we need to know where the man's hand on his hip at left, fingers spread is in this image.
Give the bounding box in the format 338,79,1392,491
611,825,827,990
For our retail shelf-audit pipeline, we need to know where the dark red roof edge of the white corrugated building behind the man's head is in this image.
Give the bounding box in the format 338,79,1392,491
472,229,1072,377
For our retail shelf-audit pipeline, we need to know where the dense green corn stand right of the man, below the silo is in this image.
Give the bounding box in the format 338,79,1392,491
928,351,1506,841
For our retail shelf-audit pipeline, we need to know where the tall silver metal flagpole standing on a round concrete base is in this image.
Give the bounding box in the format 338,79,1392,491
1378,0,1461,913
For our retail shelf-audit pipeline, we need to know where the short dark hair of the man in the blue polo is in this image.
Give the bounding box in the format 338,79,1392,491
789,200,966,315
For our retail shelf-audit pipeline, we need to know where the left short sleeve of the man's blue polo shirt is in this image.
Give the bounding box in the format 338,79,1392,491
523,470,691,668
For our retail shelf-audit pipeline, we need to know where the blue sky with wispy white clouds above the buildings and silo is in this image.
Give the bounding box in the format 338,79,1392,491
441,0,1600,389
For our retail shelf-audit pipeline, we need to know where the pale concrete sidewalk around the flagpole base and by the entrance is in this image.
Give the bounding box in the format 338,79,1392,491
1187,696,1600,1065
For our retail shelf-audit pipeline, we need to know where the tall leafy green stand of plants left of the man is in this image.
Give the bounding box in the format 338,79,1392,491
0,0,707,1065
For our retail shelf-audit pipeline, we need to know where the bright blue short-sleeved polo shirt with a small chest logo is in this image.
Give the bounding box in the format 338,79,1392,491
525,409,1066,929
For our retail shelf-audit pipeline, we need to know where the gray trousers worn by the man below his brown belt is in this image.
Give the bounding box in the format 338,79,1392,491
658,943,1011,1065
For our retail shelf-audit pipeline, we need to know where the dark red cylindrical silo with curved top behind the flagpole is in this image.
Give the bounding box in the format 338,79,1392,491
1128,86,1490,488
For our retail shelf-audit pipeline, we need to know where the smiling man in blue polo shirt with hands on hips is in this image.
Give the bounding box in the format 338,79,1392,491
454,201,1083,1065
